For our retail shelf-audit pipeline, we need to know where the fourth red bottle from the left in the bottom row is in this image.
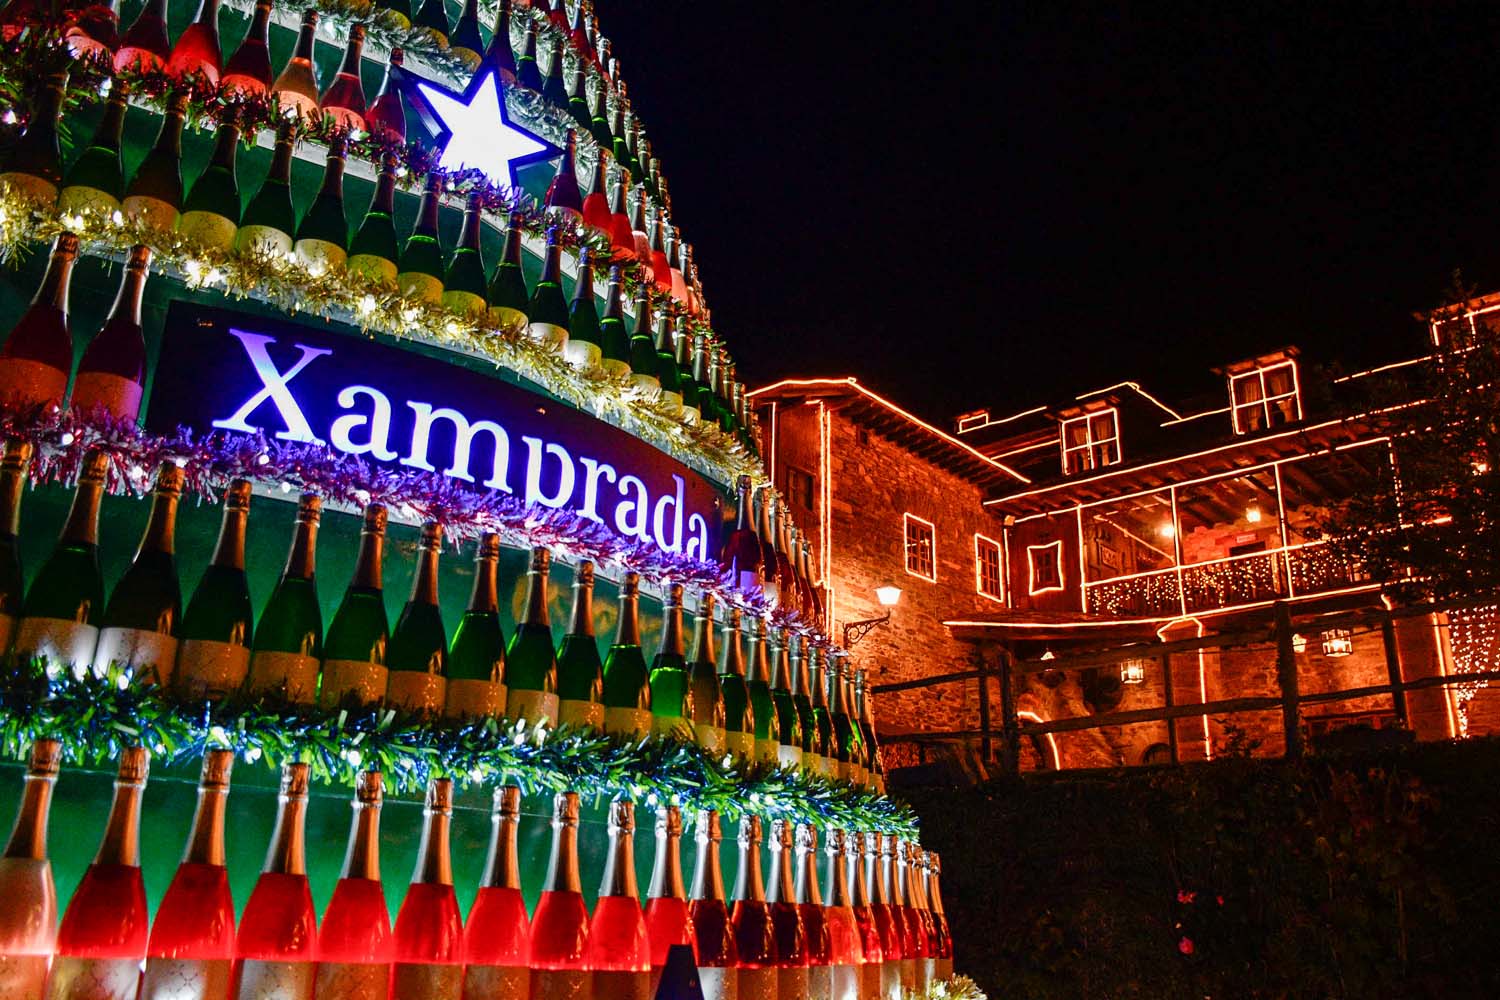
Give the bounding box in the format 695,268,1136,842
234,763,318,1000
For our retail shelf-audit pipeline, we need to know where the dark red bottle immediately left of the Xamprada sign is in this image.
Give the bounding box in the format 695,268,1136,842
71,246,152,423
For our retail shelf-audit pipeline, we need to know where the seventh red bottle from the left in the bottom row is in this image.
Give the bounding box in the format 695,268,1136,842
464,786,531,1000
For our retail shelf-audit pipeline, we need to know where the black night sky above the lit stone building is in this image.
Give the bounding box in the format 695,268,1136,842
599,0,1500,423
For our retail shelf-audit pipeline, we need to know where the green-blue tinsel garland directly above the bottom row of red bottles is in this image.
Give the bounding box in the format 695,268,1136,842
0,661,917,837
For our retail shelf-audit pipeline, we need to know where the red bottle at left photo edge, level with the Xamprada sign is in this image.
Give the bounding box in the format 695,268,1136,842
0,232,78,409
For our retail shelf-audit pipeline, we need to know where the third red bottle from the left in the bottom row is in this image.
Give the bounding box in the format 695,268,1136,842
141,750,234,1000
